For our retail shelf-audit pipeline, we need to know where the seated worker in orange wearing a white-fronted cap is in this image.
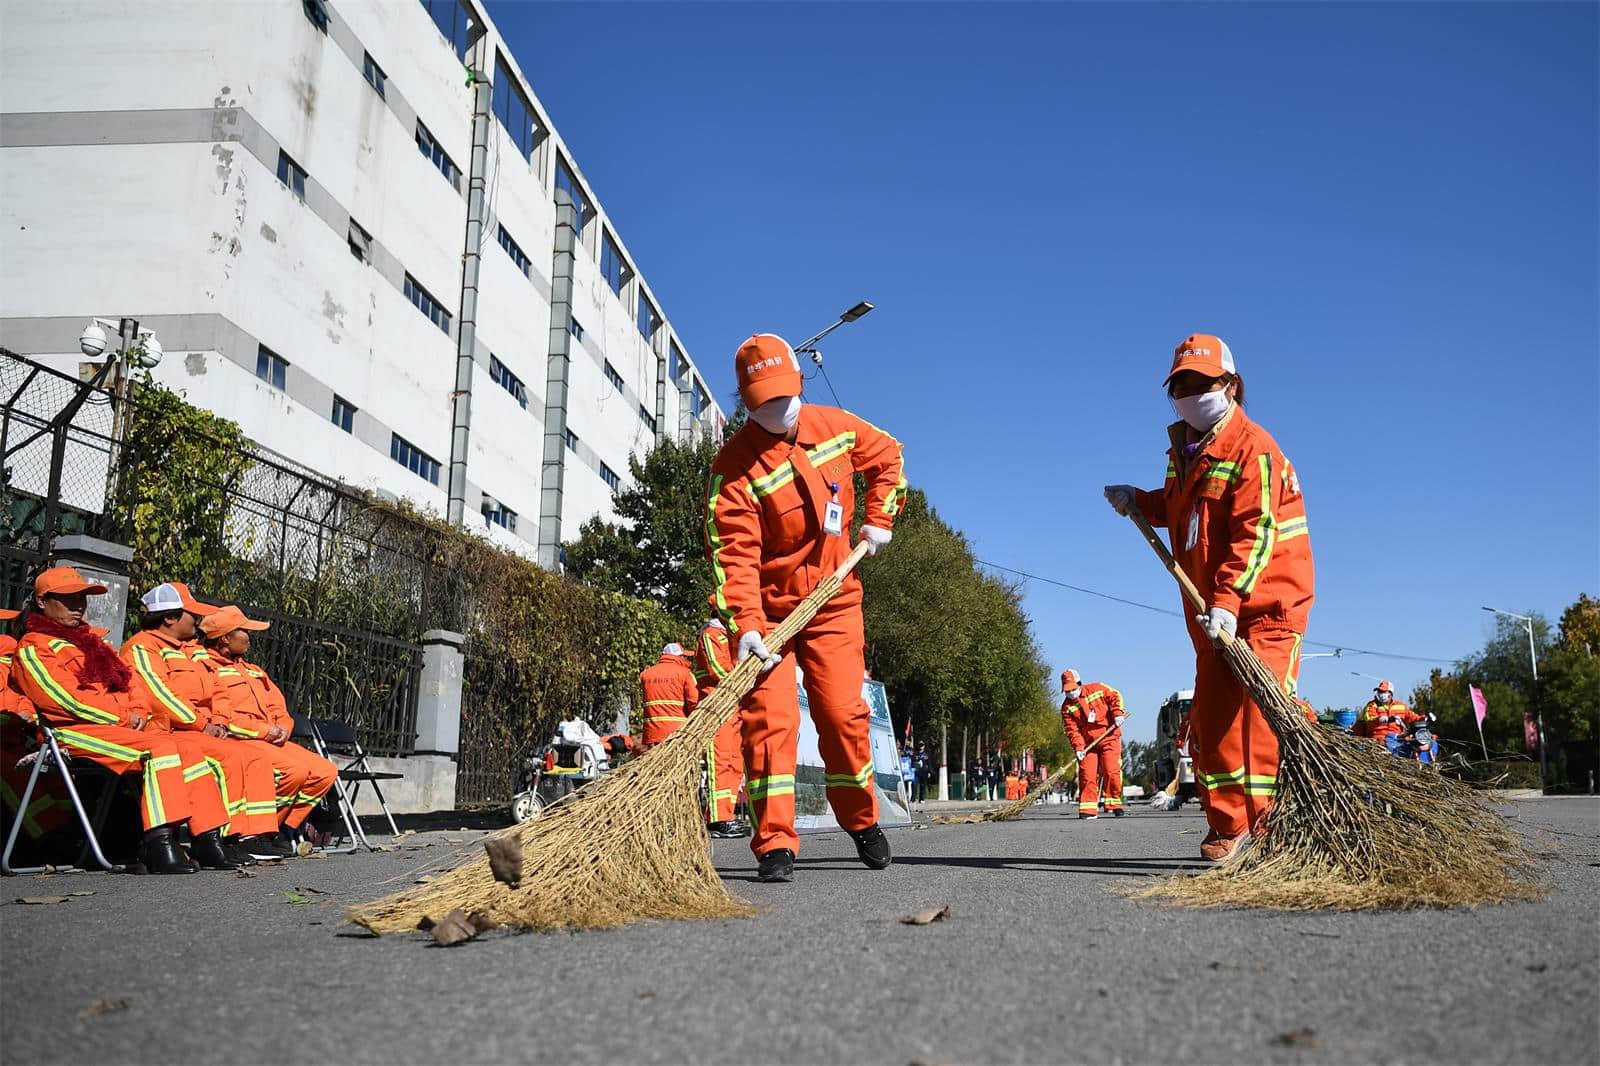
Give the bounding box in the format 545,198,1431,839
122,581,278,866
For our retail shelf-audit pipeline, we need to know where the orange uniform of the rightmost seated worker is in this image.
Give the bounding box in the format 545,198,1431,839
192,647,339,829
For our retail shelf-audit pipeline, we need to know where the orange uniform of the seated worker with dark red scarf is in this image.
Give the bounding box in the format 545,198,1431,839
11,627,229,834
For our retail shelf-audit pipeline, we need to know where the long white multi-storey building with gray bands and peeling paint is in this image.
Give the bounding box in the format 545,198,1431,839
0,0,723,562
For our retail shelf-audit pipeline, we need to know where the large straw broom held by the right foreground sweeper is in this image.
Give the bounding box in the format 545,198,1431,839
1130,511,1547,911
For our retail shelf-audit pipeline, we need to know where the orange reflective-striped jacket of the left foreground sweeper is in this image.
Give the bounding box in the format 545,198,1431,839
706,403,906,634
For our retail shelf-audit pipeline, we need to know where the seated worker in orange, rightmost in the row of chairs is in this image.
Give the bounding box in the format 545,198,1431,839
200,605,339,853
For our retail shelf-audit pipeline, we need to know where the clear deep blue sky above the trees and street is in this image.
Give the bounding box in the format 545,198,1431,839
490,2,1600,738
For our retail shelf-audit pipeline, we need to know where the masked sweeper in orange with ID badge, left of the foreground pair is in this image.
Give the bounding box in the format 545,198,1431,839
706,333,906,880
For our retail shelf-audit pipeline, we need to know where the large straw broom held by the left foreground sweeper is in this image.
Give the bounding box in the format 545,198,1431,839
350,543,869,933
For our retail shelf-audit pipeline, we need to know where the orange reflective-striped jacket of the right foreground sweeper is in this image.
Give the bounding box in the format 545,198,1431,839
1139,405,1312,650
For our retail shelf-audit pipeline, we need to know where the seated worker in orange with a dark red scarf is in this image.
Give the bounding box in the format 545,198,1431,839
11,567,238,874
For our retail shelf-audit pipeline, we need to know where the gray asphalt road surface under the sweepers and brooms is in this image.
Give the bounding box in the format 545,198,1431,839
0,799,1600,1064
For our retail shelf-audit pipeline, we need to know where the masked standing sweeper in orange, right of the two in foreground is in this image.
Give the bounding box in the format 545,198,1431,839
1106,333,1314,861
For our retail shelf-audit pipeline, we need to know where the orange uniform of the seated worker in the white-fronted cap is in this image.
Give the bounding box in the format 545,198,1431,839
122,629,278,836
